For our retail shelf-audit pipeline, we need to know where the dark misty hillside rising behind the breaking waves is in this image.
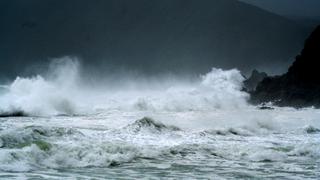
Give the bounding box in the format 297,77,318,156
0,0,306,75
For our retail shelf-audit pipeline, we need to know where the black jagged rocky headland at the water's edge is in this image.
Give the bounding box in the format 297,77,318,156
251,26,320,107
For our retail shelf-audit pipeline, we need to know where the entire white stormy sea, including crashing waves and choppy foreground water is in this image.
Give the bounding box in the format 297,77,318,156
0,57,320,179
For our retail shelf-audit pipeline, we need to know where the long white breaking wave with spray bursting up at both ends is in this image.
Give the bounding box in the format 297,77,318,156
0,57,248,117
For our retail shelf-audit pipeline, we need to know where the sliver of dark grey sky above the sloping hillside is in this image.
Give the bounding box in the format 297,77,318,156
240,0,320,18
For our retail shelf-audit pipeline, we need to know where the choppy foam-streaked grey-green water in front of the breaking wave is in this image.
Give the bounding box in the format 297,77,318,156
0,109,320,179
